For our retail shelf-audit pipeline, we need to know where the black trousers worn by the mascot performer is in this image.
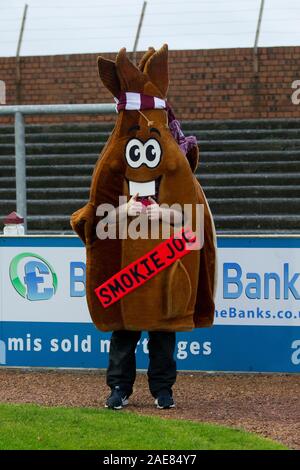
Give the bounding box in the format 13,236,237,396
106,330,177,398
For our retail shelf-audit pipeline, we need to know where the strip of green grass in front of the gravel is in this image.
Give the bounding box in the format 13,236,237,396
0,404,285,450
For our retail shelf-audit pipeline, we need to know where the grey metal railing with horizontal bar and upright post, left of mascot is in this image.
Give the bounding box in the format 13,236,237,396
0,104,116,233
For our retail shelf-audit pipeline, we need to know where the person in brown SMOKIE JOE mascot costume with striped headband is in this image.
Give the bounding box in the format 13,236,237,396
71,45,216,409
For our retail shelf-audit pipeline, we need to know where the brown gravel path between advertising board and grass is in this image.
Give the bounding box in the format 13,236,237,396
0,369,300,449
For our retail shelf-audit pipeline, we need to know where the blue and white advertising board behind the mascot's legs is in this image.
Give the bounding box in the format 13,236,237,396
0,236,300,373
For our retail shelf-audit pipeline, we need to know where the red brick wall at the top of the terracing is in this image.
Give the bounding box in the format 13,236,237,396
0,47,300,122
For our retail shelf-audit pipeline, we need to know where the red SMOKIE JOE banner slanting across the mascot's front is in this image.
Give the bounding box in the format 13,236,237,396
95,228,197,308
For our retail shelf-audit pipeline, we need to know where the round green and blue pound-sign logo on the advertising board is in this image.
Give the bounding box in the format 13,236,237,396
9,253,57,301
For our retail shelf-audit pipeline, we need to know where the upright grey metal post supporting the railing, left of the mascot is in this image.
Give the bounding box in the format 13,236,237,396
15,111,27,233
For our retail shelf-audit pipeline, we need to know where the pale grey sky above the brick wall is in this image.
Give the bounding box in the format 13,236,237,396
0,0,300,56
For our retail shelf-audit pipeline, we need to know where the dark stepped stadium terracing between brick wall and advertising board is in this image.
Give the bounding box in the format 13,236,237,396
0,119,300,234
